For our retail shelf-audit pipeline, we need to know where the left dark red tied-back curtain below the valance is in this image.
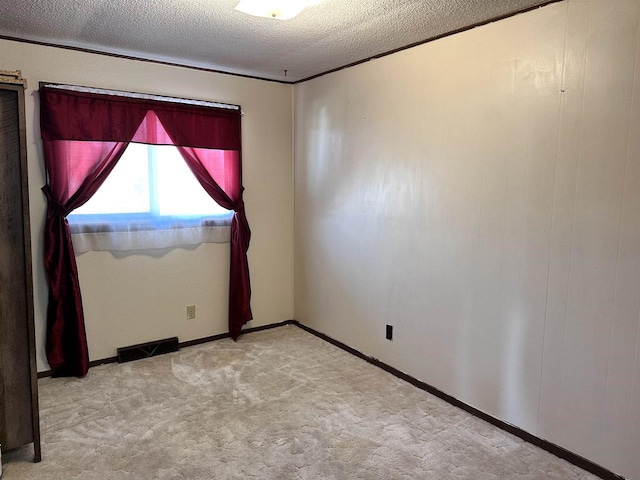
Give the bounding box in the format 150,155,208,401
42,140,128,377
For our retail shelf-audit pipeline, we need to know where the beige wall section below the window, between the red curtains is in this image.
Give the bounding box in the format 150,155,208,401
77,244,229,359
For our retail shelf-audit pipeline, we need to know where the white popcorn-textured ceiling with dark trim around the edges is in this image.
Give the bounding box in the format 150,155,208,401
0,0,557,82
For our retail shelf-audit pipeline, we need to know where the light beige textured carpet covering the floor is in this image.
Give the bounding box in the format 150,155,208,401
3,325,596,480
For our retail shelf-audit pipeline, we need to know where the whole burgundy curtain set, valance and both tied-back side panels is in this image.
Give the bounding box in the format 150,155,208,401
40,86,253,376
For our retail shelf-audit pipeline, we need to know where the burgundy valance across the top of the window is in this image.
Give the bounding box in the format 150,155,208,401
40,86,241,150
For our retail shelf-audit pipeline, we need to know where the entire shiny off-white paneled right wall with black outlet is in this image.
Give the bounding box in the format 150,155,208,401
294,0,640,479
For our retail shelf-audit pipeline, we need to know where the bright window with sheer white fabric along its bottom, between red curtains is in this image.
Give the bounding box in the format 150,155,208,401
67,143,233,253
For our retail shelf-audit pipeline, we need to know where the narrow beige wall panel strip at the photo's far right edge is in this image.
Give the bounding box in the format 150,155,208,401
601,4,640,478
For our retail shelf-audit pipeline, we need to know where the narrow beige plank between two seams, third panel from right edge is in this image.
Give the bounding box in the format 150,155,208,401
537,1,590,438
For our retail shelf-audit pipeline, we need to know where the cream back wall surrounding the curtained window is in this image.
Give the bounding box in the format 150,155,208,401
0,40,293,370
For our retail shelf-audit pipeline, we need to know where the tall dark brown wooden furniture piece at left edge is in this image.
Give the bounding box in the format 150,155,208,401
0,74,40,461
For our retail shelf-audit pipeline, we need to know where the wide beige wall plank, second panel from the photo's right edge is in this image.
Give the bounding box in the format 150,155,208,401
558,1,640,462
